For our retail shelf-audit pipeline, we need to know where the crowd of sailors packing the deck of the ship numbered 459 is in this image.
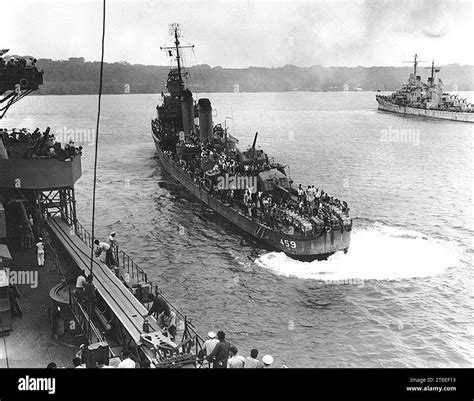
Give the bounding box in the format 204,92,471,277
164,130,349,234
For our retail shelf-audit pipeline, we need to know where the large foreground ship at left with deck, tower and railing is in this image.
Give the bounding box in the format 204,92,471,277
0,49,209,368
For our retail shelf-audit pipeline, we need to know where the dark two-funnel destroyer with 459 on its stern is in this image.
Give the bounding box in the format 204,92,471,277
151,24,352,261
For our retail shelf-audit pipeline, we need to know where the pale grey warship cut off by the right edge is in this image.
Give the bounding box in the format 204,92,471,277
375,54,474,123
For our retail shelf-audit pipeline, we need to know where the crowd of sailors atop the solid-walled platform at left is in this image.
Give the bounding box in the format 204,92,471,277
0,127,82,161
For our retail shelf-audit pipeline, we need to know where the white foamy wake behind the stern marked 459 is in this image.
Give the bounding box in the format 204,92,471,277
255,224,460,284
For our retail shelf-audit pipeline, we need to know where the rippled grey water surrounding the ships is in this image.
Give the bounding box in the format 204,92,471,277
2,92,474,367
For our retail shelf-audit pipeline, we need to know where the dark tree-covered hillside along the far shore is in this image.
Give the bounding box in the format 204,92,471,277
37,57,474,95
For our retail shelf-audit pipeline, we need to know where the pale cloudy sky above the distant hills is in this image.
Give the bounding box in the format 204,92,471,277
0,0,474,68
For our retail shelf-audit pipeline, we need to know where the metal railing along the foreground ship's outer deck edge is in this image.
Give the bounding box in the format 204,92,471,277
74,221,209,368
